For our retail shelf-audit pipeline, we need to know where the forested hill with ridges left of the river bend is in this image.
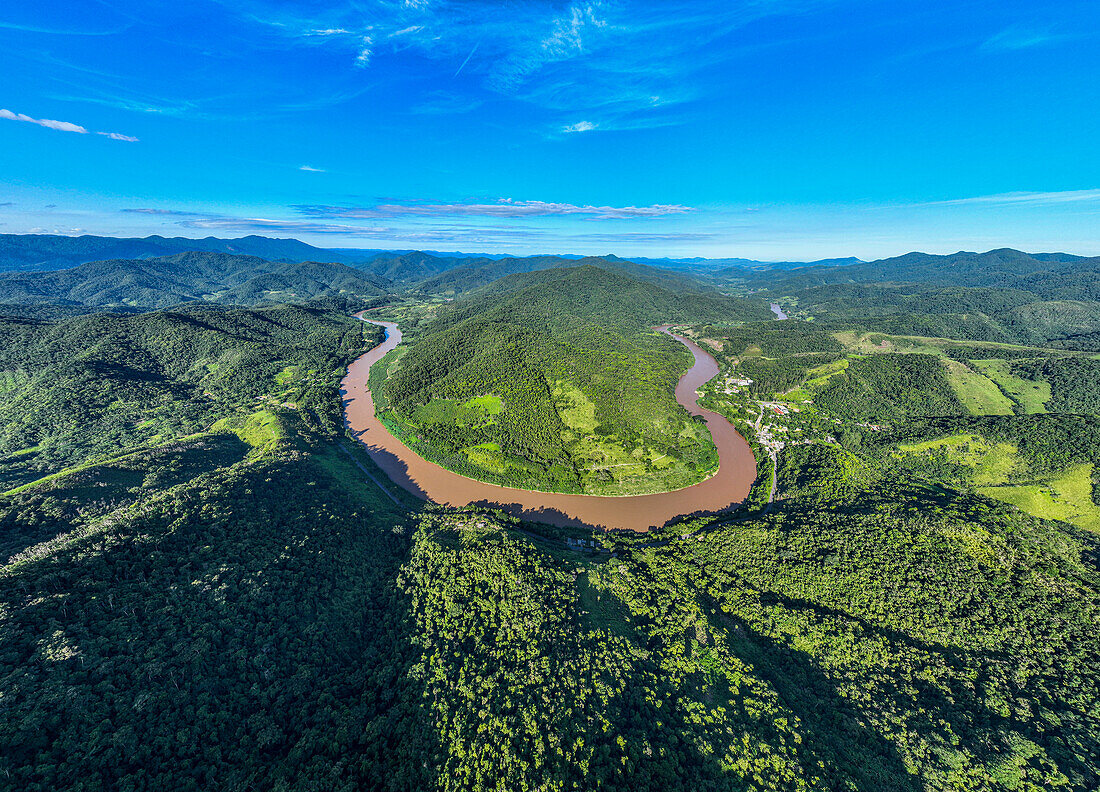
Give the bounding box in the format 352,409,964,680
0,306,361,474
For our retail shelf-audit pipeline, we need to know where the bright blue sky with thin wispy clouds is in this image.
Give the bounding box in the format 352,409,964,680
0,0,1100,261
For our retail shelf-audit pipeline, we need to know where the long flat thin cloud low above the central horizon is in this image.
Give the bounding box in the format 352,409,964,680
292,198,693,220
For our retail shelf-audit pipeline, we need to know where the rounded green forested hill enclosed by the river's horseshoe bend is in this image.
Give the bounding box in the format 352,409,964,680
380,264,770,494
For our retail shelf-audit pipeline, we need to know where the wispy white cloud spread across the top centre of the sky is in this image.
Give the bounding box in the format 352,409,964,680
232,0,827,131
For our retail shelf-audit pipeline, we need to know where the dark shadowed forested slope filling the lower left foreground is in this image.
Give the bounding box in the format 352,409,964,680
0,451,439,792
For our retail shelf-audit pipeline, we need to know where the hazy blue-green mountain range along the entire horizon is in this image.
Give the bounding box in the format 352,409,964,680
0,234,1100,350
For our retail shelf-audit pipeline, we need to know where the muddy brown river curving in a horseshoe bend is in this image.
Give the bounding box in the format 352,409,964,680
340,316,756,531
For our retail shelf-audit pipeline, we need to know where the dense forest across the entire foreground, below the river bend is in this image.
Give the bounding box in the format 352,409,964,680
0,387,1100,790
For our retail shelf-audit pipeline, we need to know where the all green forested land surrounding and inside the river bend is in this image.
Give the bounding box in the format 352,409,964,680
0,244,1100,792
